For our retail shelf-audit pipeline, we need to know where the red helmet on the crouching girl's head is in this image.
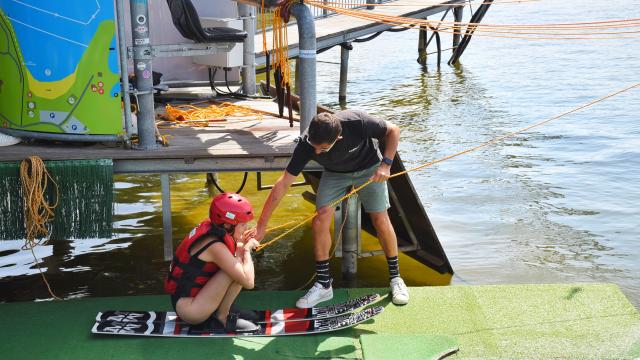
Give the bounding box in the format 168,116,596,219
209,193,253,225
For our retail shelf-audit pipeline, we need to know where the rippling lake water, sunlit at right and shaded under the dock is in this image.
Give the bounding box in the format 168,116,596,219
0,1,640,306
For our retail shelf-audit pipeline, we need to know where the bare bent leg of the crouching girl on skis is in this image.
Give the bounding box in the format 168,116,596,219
176,271,235,324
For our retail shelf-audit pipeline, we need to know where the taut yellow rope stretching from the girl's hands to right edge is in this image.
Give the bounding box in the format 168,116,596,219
256,83,640,251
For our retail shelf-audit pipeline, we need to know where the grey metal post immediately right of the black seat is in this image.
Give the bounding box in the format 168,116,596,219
238,3,256,95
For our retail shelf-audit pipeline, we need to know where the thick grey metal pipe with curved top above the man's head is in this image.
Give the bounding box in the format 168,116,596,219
291,3,317,134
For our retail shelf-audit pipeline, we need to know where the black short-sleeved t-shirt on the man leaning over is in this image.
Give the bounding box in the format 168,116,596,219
287,110,387,176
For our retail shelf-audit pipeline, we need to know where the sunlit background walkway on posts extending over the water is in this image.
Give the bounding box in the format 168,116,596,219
255,0,465,65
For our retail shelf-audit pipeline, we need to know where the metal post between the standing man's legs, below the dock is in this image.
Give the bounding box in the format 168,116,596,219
336,194,361,280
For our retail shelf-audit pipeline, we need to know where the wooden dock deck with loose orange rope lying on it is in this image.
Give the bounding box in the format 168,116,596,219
0,99,320,173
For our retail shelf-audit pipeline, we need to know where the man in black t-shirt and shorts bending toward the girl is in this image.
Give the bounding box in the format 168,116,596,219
249,110,409,308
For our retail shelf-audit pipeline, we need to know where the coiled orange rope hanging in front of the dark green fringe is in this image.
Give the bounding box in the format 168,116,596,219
20,156,61,300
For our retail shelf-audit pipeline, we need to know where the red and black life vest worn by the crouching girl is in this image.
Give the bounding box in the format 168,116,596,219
164,219,236,297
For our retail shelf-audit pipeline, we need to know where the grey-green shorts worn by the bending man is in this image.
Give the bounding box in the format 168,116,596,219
316,165,389,213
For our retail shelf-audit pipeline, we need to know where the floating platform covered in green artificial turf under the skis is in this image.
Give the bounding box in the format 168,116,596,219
0,284,640,360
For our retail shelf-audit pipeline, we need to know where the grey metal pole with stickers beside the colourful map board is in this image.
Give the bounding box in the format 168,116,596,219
129,0,158,150
